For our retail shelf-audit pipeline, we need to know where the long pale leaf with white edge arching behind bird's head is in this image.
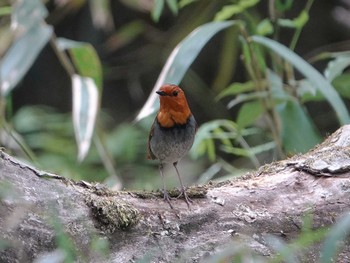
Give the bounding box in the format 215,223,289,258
136,21,239,121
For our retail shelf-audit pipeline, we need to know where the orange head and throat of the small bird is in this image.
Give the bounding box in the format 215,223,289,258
156,84,191,128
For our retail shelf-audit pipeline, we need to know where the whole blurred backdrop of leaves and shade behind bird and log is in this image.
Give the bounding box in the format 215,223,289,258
0,0,350,260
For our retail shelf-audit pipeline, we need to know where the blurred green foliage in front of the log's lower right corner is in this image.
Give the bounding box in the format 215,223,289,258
205,213,350,263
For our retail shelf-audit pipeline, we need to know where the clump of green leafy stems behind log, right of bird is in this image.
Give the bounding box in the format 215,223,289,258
182,1,350,169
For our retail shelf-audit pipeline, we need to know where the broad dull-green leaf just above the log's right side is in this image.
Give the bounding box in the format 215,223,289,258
276,101,321,153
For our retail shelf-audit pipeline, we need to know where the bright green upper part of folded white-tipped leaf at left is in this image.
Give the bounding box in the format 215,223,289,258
56,38,102,89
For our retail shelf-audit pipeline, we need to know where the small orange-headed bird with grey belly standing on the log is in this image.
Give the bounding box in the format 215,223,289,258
148,84,198,209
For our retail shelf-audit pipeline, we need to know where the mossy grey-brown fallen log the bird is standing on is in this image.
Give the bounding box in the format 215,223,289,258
0,125,350,262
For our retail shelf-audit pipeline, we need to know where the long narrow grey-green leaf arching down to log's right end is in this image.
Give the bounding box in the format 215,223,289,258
252,36,350,124
